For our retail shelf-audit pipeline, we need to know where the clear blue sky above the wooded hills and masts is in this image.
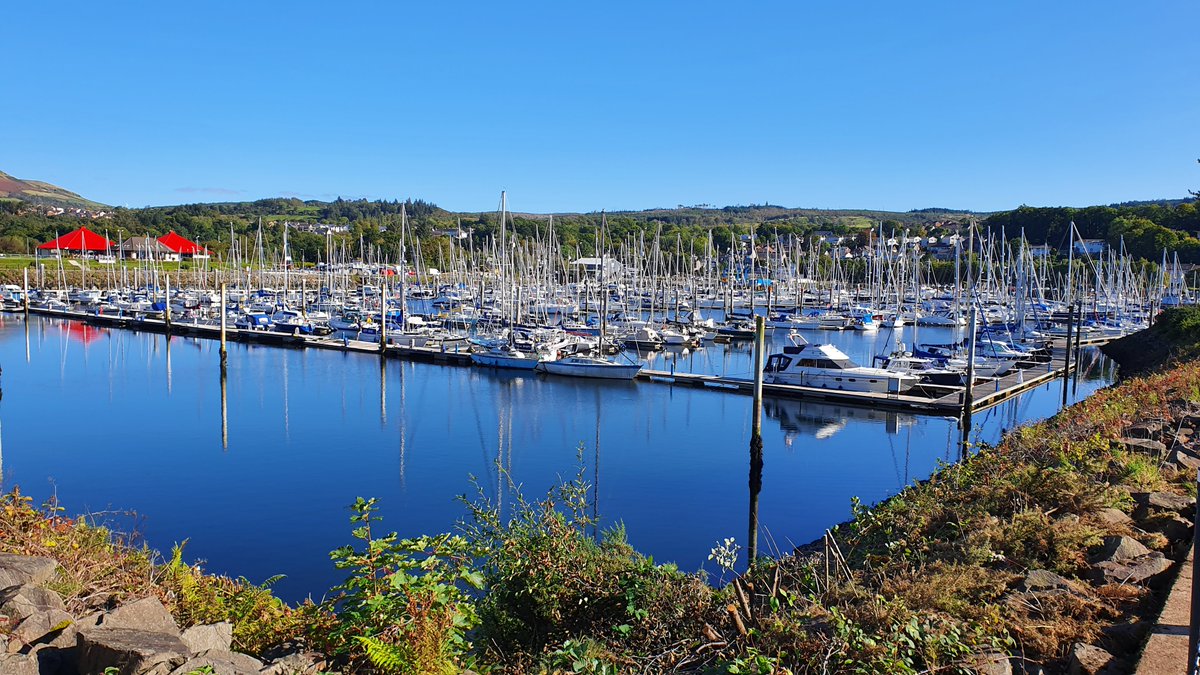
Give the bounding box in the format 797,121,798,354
0,0,1200,211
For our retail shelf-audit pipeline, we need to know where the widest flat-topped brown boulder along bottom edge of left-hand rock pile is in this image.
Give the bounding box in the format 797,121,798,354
78,628,188,675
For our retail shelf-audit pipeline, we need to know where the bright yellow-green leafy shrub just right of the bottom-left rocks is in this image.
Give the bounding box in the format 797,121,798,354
328,497,482,674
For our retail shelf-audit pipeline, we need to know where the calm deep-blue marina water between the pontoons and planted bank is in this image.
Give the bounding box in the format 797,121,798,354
0,316,1112,599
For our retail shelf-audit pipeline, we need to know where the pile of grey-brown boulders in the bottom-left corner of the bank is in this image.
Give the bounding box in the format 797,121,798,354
0,554,324,675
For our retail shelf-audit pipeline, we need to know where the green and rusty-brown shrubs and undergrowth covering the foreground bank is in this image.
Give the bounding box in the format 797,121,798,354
0,309,1200,674
